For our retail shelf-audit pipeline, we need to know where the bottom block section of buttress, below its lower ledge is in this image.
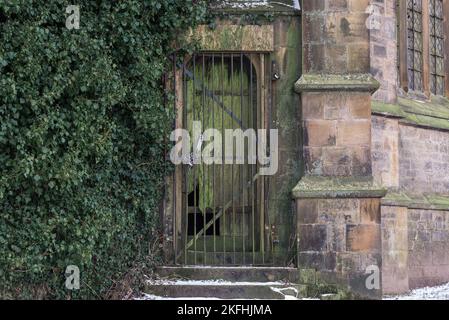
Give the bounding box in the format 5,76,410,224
297,199,381,297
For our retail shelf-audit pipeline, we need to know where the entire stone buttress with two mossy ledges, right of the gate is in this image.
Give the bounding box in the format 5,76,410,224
293,0,385,298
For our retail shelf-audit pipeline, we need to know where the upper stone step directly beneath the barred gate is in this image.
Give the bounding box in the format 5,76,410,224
156,266,299,283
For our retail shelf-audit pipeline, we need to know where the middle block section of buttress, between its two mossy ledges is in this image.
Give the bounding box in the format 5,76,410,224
303,92,371,176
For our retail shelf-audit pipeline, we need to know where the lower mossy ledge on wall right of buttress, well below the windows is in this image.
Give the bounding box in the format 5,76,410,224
382,192,449,211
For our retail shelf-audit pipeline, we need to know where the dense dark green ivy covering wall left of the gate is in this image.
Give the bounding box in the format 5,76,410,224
0,0,207,298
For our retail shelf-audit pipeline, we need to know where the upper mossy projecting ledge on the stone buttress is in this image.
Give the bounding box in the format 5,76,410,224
295,74,380,93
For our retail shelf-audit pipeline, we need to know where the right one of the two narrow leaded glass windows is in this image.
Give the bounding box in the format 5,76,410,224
429,0,445,95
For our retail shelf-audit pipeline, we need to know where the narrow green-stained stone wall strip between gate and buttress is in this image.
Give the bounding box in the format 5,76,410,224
265,15,303,266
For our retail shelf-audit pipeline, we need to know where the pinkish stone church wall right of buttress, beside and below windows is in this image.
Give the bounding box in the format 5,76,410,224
370,0,449,294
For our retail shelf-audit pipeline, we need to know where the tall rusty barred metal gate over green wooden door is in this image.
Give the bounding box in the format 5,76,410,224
174,52,266,265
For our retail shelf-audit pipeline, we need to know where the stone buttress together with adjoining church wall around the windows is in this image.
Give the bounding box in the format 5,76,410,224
293,0,449,297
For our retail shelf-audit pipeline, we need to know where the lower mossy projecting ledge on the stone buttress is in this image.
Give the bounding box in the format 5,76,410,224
292,176,387,199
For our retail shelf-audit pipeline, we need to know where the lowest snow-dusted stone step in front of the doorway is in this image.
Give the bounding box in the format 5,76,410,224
145,280,302,300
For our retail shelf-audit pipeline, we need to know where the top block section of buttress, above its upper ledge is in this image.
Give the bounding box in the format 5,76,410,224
303,0,370,74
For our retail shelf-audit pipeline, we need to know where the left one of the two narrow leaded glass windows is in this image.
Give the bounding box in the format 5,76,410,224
407,0,423,91
